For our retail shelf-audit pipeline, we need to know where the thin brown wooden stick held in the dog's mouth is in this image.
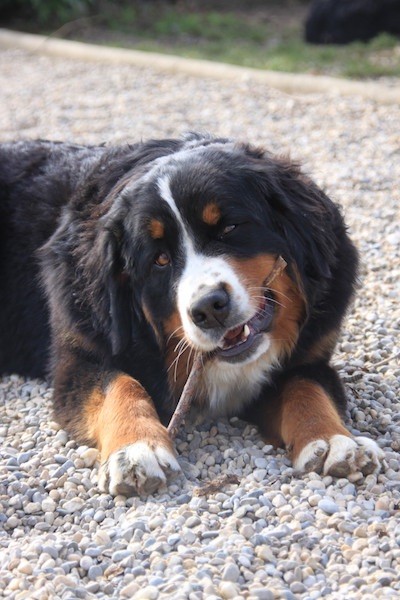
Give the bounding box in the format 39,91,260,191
168,256,287,439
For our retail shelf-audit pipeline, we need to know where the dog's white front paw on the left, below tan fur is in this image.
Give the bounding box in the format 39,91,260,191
99,441,180,496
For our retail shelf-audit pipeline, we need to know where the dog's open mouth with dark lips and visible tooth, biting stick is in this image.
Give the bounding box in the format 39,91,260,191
216,298,274,359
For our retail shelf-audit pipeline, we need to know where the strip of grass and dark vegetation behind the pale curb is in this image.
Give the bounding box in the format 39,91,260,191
6,0,400,78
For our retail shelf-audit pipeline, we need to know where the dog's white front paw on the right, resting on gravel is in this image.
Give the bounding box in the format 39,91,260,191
294,435,384,477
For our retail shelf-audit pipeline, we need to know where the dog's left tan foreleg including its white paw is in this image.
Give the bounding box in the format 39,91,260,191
85,374,180,495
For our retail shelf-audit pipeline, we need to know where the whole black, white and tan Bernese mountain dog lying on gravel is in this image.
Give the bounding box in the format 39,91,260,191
0,134,383,495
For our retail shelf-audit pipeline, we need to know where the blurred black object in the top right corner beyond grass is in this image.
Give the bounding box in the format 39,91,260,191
305,0,400,44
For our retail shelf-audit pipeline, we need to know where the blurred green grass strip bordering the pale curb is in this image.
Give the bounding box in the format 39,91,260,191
105,22,400,79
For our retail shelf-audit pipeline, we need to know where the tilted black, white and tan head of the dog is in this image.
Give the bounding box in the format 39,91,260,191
86,136,342,406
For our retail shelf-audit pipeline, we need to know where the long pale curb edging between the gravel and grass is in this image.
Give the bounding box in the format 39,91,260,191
0,28,400,104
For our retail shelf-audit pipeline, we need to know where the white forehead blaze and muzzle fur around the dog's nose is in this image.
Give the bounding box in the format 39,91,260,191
158,177,254,351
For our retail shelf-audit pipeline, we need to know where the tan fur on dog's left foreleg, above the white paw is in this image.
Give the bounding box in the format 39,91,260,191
84,374,172,461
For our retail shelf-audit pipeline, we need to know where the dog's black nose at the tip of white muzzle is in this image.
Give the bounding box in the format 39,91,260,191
189,288,230,329
